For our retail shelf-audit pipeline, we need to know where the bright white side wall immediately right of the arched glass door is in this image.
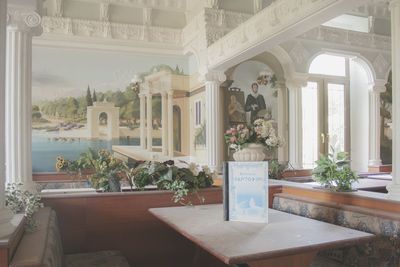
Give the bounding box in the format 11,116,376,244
350,61,369,172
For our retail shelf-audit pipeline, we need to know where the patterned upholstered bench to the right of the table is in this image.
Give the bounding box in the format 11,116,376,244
273,194,400,267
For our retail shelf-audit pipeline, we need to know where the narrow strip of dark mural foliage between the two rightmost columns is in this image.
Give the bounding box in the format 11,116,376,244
381,72,392,164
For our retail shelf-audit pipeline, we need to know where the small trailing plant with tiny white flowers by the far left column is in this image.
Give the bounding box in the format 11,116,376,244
5,183,43,232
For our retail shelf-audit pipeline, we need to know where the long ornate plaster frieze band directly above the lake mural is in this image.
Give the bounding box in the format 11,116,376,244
42,17,181,45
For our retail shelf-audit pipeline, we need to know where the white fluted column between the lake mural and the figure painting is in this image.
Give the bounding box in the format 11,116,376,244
202,71,226,171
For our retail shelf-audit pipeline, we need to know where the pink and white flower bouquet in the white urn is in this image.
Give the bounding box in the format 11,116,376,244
224,119,285,151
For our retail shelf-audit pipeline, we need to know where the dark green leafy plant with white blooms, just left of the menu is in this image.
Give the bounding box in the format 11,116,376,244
126,161,214,205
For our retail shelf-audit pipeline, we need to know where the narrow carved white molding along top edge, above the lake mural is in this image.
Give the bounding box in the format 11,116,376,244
72,0,186,11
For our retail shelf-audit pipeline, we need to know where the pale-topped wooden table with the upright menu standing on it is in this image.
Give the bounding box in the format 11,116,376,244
149,205,374,267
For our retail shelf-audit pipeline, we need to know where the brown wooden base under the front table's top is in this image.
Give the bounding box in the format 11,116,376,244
247,251,317,267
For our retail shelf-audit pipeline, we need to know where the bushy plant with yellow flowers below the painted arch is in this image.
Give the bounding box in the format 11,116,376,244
56,149,126,192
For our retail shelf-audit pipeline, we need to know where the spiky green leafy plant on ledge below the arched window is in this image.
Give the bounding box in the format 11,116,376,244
312,148,358,192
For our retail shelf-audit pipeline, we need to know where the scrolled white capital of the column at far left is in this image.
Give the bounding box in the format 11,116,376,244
7,0,42,35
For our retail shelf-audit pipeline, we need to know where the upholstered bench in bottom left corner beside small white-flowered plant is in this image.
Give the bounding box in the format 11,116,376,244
10,207,130,267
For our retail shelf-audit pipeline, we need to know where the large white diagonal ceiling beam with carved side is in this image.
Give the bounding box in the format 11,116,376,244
208,0,363,69
